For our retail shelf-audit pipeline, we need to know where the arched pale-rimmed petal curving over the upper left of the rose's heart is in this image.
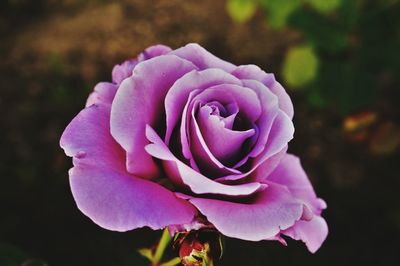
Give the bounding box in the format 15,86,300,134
165,68,241,145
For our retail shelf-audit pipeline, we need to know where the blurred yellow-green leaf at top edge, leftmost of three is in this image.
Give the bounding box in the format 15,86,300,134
226,0,257,23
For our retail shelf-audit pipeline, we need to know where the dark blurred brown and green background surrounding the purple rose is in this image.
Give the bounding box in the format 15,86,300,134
0,0,400,266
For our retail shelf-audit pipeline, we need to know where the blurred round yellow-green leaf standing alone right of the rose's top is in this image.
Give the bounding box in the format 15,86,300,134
283,46,319,88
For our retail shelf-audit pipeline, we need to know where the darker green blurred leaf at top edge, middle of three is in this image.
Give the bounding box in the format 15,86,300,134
261,0,301,29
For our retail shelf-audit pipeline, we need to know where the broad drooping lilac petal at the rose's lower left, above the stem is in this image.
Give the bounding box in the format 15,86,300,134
70,167,196,231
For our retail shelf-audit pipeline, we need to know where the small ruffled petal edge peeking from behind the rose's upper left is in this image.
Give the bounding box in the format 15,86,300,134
112,44,171,84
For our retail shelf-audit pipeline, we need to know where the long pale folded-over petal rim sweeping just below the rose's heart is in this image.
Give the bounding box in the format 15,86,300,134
145,126,265,196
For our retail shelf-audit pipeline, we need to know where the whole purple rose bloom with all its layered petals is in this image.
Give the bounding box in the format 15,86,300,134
60,44,328,252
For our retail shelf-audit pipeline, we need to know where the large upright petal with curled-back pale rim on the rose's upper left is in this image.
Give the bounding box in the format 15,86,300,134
111,55,196,178
